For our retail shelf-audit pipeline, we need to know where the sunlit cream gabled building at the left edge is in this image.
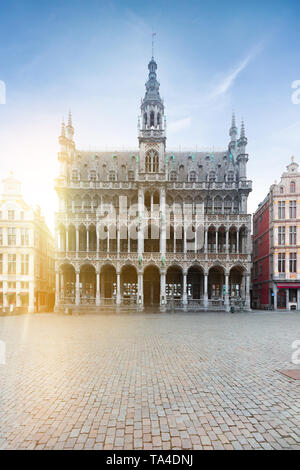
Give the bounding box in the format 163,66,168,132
0,174,55,312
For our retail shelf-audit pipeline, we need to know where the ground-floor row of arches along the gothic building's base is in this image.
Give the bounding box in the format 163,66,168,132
56,263,250,310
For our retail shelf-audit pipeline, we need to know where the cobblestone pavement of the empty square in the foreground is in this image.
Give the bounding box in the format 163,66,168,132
0,312,300,449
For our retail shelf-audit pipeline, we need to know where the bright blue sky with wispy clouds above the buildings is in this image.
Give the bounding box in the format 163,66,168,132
0,0,300,233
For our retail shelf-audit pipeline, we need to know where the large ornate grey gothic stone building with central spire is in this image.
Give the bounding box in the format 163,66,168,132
55,58,252,311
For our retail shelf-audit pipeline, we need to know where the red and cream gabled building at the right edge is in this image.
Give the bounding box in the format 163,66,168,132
252,157,300,310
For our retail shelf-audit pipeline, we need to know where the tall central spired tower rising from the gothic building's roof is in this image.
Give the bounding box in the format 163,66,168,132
138,57,166,173
